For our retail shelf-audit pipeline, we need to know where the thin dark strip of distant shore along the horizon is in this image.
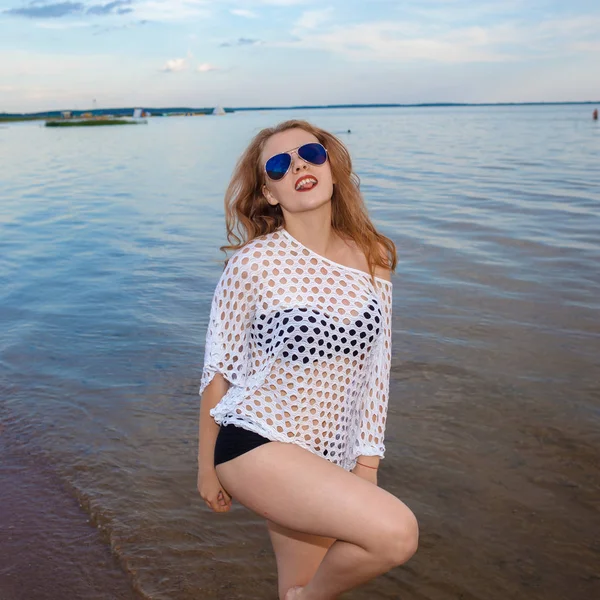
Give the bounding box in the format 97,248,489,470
0,100,600,121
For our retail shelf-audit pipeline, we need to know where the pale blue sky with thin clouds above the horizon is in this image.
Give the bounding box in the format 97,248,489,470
0,0,600,113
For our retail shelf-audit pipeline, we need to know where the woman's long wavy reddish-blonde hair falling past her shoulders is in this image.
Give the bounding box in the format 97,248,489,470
221,120,397,277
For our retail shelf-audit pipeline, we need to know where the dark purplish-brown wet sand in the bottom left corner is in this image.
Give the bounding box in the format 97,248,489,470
0,424,141,600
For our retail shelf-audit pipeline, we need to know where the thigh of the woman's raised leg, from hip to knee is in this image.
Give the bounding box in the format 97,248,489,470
216,442,416,550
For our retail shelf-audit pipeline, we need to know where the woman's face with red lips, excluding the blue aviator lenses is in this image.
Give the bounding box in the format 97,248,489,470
260,129,334,213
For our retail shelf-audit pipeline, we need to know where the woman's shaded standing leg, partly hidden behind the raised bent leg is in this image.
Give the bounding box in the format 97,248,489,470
267,520,335,600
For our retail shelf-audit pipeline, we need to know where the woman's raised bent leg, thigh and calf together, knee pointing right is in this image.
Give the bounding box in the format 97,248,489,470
216,442,418,600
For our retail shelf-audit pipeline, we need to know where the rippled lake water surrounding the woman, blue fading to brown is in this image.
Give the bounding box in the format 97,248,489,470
0,106,600,600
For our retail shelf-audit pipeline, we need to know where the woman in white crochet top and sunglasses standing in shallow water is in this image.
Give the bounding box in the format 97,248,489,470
198,121,418,600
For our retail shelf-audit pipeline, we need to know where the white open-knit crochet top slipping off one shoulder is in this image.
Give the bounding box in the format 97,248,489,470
200,229,392,470
